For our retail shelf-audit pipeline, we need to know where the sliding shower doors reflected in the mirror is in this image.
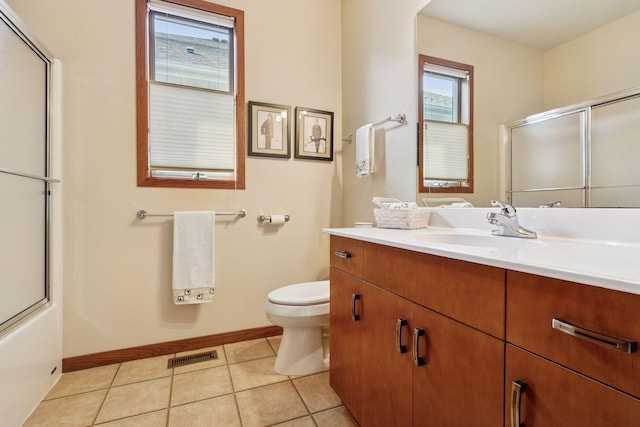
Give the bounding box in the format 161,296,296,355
503,88,640,208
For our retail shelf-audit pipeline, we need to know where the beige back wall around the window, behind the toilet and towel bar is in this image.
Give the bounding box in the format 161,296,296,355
9,0,342,357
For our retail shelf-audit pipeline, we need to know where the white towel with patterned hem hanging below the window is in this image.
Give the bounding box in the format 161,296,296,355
173,211,216,304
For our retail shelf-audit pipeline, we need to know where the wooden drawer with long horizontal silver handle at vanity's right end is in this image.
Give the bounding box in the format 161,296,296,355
507,271,640,397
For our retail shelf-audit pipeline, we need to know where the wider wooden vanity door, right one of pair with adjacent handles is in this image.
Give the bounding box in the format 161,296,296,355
413,306,504,427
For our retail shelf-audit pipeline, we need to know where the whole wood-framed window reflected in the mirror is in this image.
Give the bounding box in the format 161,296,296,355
418,55,473,193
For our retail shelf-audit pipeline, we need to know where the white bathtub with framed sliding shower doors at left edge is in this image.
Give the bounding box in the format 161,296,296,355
0,0,62,426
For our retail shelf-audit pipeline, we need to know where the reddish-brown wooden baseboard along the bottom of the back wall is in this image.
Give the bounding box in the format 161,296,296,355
62,326,282,372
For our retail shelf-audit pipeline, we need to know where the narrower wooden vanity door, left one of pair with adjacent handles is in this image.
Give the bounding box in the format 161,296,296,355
362,284,413,427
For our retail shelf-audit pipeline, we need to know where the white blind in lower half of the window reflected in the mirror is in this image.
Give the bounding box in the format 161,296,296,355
423,121,469,180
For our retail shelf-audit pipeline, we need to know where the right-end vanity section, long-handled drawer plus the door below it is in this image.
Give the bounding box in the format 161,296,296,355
505,271,640,427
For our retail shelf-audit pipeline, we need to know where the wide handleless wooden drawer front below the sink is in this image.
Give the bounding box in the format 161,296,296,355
364,242,505,339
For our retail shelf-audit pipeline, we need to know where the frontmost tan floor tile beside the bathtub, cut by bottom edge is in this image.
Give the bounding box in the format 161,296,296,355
23,390,107,427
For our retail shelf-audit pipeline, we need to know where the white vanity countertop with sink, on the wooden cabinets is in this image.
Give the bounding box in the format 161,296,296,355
324,216,640,295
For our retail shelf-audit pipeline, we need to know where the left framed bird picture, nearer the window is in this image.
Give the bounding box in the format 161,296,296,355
248,101,291,159
